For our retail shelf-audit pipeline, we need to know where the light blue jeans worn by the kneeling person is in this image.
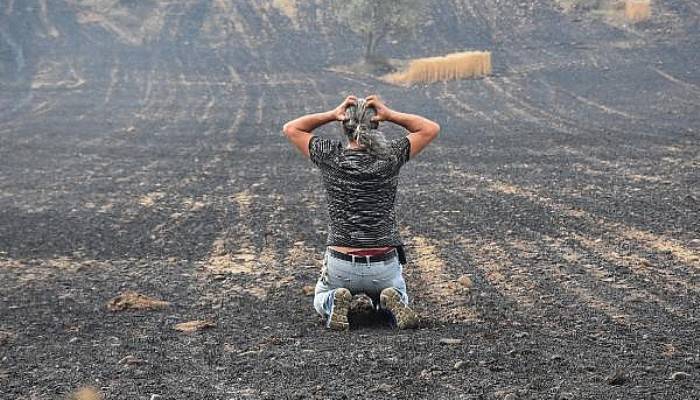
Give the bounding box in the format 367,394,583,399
314,251,408,317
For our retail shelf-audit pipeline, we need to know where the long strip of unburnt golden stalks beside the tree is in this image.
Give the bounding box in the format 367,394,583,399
383,51,492,85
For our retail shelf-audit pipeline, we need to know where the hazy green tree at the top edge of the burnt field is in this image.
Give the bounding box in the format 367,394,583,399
334,0,425,62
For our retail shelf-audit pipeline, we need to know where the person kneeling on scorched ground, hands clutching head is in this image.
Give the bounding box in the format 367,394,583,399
283,96,440,330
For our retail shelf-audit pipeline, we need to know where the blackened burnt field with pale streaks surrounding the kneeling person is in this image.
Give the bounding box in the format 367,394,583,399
0,0,700,400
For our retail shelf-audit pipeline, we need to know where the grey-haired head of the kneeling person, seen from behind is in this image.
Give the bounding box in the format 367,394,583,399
343,99,390,157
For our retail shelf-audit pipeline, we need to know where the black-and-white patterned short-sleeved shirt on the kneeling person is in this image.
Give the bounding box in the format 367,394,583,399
309,136,411,248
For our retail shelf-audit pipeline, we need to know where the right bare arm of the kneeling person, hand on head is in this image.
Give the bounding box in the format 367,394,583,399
367,96,440,158
